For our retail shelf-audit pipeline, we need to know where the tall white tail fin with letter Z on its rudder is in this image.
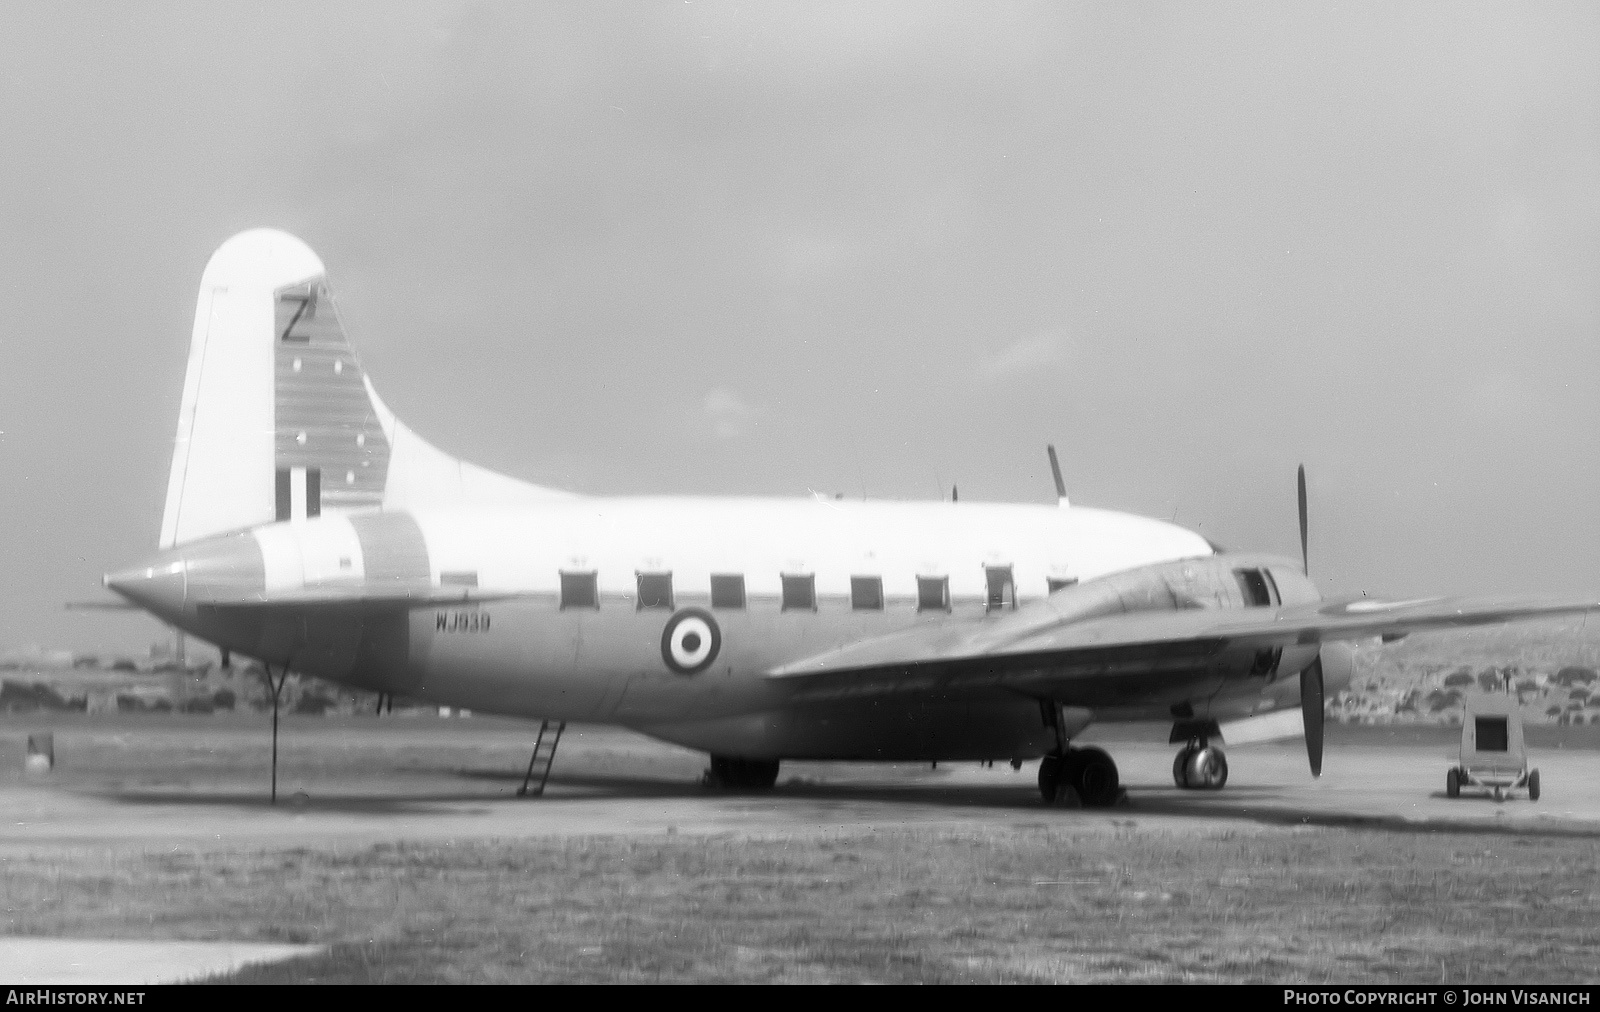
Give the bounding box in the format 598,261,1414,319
160,229,570,549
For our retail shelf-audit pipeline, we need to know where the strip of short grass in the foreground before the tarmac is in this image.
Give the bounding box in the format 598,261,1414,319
0,820,1600,983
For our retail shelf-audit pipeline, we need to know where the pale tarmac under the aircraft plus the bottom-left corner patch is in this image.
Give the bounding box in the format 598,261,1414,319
0,714,1600,983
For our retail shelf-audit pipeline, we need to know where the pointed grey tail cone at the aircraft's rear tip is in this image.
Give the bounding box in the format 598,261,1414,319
106,535,266,616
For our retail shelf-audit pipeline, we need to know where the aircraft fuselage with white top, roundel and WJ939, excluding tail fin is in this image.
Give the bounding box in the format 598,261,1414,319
109,498,1324,759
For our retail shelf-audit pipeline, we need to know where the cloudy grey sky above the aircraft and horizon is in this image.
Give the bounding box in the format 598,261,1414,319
0,0,1600,650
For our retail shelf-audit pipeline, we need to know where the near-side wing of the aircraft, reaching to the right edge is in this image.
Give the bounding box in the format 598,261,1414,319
766,597,1600,700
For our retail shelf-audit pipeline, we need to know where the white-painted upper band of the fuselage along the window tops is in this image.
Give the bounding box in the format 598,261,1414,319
258,498,1211,600
